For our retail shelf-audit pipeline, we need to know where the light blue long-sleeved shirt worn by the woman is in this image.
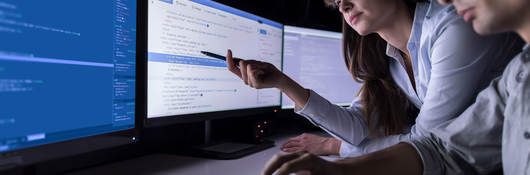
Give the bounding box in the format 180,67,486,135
295,1,522,157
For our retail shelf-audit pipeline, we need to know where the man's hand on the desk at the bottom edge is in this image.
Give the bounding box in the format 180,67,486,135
261,151,344,175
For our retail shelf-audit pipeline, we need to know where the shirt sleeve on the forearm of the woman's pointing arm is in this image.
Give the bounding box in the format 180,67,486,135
294,90,369,145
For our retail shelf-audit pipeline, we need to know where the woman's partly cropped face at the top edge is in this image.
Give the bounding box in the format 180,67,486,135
335,0,404,35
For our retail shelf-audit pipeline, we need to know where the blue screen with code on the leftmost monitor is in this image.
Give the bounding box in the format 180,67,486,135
0,0,136,152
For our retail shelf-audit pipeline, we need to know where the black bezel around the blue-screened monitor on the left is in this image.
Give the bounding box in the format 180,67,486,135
0,0,143,172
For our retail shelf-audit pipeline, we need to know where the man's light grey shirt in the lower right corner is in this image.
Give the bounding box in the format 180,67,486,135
407,45,530,175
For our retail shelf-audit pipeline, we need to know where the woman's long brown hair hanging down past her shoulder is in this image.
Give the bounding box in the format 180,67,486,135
324,0,424,137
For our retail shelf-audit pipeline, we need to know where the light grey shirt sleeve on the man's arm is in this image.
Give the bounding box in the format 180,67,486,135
405,63,508,175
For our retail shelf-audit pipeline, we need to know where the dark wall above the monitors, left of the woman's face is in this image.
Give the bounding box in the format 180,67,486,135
215,0,342,32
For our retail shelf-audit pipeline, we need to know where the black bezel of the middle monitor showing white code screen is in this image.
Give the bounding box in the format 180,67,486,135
137,1,284,128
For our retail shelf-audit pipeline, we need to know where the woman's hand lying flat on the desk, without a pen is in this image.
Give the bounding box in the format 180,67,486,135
281,133,341,156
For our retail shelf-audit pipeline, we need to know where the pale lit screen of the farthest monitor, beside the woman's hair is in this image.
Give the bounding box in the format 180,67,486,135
282,26,361,109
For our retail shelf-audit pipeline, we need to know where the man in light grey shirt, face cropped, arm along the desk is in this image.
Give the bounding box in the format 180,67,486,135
263,0,530,175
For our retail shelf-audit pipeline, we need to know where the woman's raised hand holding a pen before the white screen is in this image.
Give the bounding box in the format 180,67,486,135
226,50,285,89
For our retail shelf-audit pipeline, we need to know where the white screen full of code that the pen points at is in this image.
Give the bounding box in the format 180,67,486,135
147,0,283,118
